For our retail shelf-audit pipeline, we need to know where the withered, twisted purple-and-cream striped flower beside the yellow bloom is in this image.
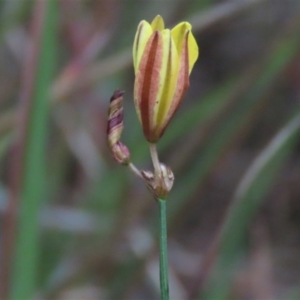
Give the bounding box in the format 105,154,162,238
107,90,130,165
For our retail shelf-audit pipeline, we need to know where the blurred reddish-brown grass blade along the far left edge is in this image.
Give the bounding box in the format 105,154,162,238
0,1,46,298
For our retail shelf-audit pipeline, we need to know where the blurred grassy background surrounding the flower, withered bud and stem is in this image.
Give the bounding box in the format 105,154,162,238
0,0,300,300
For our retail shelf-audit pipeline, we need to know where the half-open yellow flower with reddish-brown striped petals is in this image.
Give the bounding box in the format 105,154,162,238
133,16,198,143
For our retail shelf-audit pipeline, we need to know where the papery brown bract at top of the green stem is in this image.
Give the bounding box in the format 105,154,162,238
141,163,174,199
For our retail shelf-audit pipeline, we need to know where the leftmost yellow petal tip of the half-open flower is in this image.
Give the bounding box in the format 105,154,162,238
132,21,153,74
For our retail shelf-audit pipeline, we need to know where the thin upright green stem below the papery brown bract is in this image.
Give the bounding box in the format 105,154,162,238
157,199,169,300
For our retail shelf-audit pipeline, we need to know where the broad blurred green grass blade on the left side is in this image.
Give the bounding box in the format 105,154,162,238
10,0,57,299
